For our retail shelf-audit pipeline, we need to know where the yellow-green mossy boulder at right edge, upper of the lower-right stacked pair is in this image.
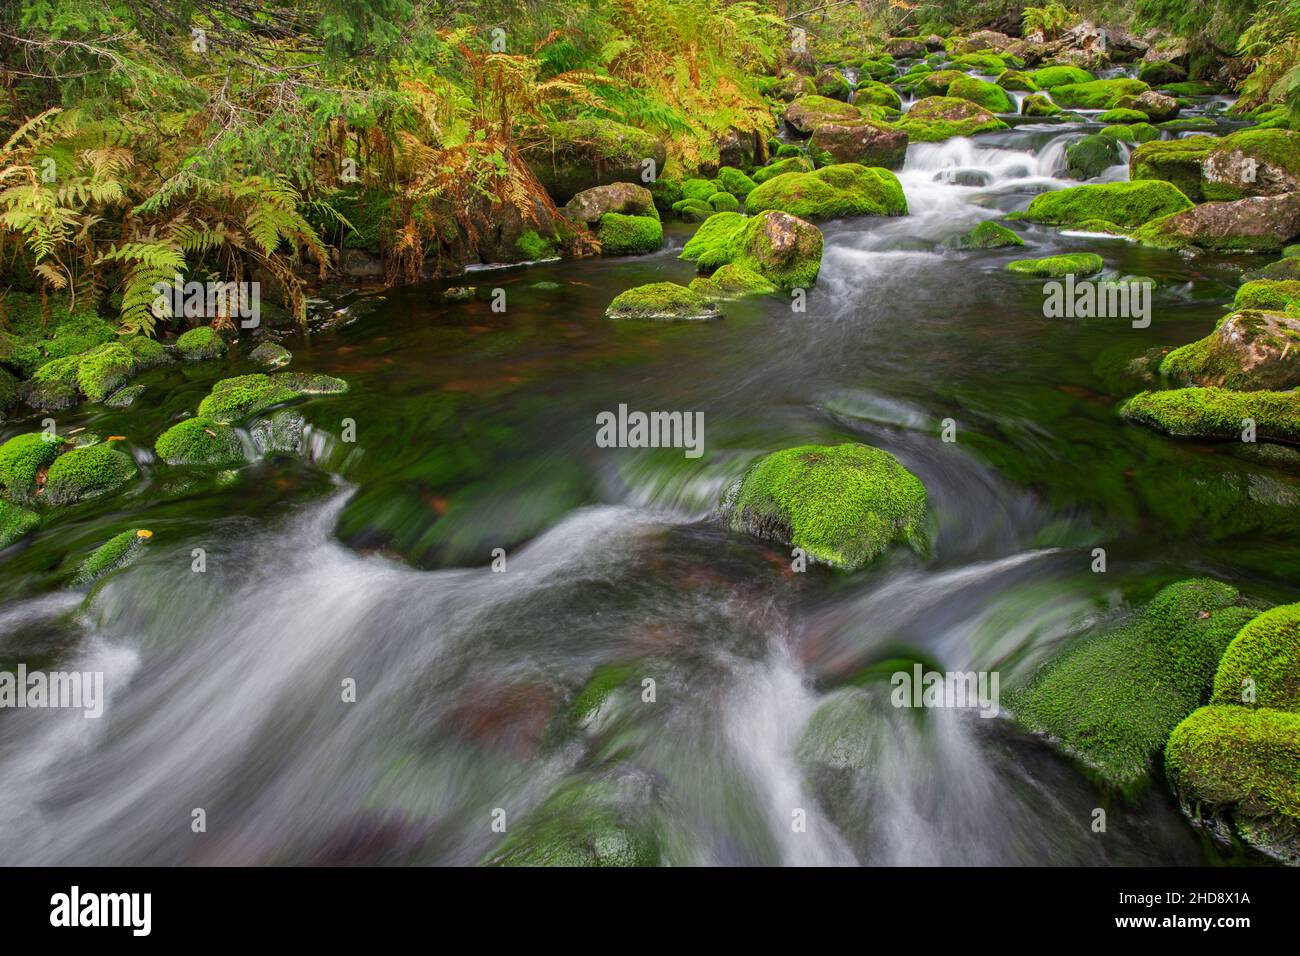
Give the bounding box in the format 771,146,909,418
1212,604,1300,712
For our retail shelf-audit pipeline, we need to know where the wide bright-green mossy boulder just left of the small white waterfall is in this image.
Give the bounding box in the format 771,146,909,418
745,163,907,220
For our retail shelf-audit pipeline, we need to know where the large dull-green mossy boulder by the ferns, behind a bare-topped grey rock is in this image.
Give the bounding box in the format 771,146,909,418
524,117,667,203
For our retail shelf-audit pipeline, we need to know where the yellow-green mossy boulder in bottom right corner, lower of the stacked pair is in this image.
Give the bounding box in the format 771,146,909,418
1165,705,1300,865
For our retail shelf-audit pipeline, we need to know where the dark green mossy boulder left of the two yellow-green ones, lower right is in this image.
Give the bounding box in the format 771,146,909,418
1006,579,1255,791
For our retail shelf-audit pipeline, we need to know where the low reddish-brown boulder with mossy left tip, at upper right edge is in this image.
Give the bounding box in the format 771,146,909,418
1132,192,1300,252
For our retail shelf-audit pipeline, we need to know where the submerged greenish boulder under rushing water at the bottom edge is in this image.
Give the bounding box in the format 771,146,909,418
482,775,662,866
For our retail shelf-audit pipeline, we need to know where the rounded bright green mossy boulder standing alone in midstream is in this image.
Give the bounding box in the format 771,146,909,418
725,444,927,570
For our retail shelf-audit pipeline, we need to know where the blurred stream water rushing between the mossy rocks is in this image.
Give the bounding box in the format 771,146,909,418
0,80,1300,865
